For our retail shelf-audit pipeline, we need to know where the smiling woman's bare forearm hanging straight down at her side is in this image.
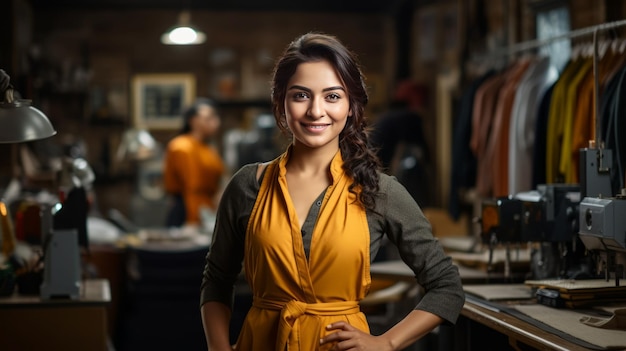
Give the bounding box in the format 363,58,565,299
200,301,232,351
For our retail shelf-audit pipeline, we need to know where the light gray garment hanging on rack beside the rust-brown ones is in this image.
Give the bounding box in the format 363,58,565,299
505,57,558,194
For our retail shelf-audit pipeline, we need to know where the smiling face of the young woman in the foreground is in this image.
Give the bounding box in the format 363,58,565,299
285,60,350,148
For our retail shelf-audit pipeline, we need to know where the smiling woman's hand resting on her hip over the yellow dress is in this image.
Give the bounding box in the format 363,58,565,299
320,322,393,351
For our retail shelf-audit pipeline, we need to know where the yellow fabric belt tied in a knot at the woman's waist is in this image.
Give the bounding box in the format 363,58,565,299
252,297,361,351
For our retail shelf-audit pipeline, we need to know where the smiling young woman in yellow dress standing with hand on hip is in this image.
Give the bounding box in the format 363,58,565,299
201,33,464,351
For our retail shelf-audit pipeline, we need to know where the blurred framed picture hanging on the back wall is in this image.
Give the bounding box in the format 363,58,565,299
131,73,196,129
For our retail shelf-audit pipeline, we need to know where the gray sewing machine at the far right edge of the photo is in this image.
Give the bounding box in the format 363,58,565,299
579,148,626,286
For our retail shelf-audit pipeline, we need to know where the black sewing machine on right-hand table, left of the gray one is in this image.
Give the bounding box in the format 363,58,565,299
481,184,588,279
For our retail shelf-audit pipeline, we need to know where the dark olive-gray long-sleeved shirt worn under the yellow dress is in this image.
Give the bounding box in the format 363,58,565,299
200,164,465,323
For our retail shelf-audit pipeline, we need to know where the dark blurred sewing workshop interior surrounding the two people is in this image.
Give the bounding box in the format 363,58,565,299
0,0,626,351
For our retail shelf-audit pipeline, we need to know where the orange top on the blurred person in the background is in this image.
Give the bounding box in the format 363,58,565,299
163,134,224,223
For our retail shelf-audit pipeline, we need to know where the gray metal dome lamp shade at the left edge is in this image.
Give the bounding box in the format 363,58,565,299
0,99,56,143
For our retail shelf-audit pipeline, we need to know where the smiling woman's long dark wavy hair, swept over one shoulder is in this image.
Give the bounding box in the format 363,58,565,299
272,33,380,210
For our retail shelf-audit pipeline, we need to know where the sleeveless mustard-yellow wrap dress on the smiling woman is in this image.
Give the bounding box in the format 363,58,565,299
237,152,371,351
